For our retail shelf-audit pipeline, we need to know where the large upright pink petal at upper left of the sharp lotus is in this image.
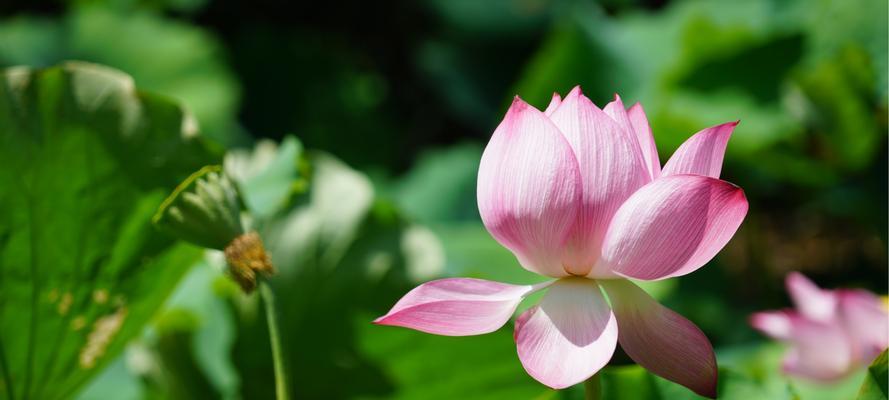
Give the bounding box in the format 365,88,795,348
477,97,582,277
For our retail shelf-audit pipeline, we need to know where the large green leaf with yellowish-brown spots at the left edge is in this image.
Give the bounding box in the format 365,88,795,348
0,63,213,399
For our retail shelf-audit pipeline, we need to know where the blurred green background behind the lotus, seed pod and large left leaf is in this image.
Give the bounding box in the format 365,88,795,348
0,0,889,399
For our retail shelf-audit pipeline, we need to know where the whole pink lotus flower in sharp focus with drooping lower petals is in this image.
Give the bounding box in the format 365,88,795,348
375,87,747,397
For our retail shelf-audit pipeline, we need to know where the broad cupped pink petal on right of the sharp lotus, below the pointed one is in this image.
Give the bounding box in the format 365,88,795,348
602,175,747,280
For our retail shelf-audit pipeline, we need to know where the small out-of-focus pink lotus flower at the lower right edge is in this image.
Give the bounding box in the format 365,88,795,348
750,272,889,382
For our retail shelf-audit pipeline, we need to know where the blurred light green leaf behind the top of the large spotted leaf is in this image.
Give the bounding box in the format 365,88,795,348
0,3,241,144
